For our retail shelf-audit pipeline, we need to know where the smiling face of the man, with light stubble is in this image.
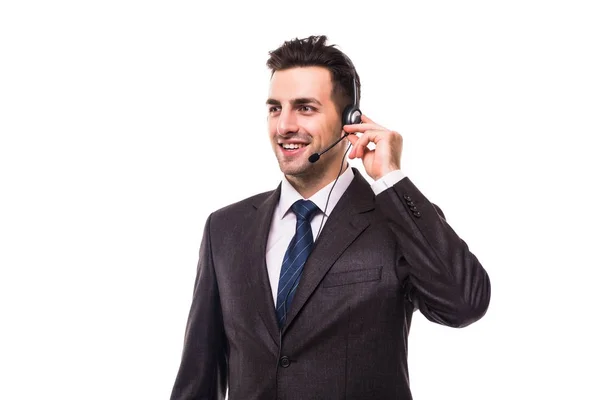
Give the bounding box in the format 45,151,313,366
267,67,345,179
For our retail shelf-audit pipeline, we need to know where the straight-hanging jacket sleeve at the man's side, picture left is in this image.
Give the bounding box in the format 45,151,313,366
170,216,227,400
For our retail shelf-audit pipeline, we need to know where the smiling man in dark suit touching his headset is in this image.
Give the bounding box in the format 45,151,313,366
171,36,490,400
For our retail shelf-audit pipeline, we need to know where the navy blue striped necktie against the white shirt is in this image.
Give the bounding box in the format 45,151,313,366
276,200,319,327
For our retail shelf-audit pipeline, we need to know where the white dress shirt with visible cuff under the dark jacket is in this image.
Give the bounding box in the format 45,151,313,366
266,166,405,304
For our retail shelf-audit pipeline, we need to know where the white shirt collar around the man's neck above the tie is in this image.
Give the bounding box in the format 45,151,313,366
277,165,354,219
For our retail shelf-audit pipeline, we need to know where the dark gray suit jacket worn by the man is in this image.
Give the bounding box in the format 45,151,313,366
171,169,490,400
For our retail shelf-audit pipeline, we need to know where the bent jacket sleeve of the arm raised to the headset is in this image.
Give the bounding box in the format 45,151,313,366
376,177,491,328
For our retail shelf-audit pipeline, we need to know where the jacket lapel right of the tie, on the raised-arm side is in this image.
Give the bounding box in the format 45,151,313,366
282,169,374,333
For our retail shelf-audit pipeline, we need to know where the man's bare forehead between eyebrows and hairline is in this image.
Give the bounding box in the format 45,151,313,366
269,67,332,102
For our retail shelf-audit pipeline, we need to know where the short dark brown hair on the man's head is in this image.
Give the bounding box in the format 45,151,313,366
267,35,360,113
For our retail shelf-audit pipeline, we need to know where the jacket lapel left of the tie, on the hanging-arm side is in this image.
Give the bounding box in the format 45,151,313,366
242,185,281,351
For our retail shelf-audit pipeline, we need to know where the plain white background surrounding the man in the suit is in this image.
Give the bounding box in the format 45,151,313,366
0,0,600,400
